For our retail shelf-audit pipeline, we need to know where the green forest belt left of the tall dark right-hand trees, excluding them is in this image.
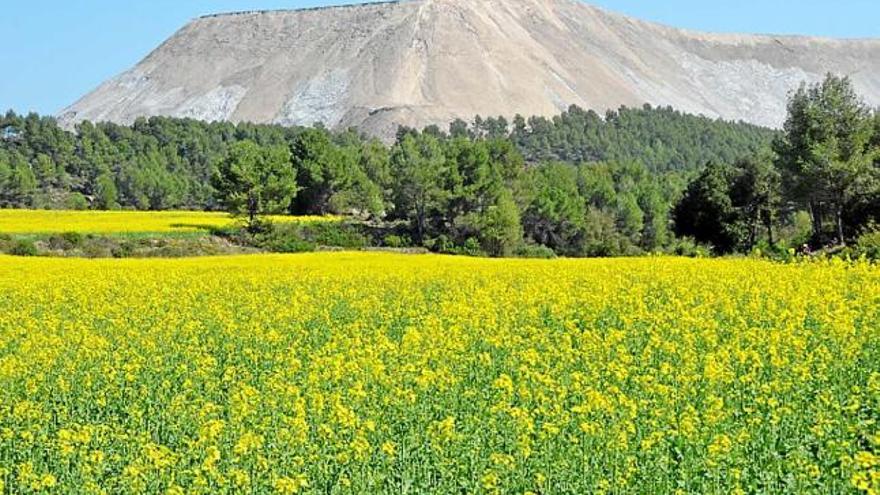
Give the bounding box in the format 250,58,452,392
0,106,775,256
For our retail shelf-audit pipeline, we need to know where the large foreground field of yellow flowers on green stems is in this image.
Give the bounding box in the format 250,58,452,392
0,253,880,494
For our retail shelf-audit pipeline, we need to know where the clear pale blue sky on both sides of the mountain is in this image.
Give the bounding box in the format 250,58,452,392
0,0,880,114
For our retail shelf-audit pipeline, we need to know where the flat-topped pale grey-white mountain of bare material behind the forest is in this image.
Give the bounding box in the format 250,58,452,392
59,0,880,138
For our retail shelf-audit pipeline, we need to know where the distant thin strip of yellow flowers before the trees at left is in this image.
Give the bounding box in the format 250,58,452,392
0,209,337,234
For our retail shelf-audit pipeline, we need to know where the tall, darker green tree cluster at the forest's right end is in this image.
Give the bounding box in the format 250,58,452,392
674,74,880,259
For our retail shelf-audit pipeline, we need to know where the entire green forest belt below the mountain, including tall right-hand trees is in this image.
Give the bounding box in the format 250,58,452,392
0,78,880,256
